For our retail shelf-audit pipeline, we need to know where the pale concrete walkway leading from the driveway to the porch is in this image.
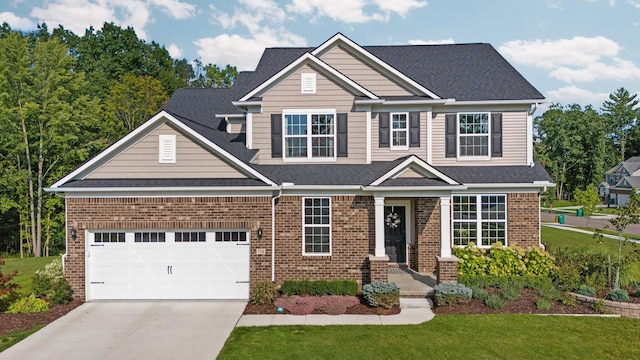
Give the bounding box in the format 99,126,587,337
236,298,435,326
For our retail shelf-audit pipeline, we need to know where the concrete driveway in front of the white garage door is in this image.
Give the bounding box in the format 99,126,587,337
0,301,246,360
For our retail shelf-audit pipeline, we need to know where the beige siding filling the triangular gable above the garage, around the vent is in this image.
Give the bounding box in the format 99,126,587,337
87,123,246,179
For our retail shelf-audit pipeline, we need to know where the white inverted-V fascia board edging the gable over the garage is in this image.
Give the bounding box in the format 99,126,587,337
51,110,276,189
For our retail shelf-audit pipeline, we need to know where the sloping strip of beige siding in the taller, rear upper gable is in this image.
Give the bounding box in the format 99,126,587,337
320,46,412,96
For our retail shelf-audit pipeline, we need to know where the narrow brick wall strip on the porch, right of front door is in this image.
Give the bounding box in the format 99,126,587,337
412,198,440,273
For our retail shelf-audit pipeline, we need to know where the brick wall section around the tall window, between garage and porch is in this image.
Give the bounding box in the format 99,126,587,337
275,196,375,286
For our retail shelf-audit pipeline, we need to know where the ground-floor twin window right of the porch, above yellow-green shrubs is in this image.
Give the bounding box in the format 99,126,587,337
452,195,507,247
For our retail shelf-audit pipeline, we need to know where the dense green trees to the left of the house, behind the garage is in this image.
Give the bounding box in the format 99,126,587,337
0,23,237,257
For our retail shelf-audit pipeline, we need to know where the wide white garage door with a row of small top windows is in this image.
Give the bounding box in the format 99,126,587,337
87,230,250,299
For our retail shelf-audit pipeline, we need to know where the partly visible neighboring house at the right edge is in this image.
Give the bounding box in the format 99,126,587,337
604,156,640,206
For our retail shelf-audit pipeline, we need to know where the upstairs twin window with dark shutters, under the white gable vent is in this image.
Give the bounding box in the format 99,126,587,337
284,110,336,159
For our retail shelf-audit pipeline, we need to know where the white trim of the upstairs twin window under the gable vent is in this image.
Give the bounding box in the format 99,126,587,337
282,109,338,162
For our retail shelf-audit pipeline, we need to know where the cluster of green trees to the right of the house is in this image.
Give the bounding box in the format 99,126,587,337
534,87,640,199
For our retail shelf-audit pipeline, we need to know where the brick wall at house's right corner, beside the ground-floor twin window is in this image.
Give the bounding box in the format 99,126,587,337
507,193,540,249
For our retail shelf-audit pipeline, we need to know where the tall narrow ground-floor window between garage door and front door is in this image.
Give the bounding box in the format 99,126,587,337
302,197,331,255
